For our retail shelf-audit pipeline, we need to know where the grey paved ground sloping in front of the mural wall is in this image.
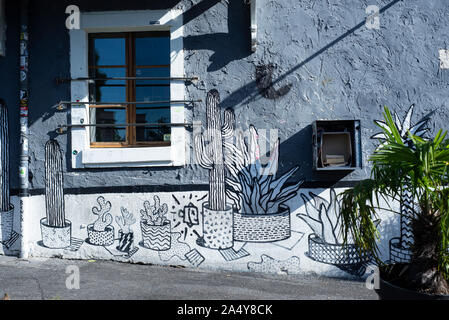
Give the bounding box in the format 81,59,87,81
0,257,377,300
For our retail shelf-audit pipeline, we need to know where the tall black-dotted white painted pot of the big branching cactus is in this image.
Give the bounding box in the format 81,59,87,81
202,202,234,250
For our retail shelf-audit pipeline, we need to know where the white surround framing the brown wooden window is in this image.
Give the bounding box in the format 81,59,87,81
70,10,187,169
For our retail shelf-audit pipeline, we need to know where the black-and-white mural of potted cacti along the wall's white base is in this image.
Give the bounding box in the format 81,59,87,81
23,90,434,277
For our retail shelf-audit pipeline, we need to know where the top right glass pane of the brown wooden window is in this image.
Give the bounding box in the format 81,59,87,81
136,32,170,66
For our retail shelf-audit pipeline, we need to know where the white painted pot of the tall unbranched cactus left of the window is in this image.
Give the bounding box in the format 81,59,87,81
41,218,72,249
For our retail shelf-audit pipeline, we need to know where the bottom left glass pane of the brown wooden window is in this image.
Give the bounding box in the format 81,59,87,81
90,108,126,142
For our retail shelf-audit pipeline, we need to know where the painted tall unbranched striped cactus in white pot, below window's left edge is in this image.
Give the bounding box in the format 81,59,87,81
41,140,72,249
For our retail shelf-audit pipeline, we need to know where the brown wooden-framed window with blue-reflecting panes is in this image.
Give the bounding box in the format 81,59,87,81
89,31,171,148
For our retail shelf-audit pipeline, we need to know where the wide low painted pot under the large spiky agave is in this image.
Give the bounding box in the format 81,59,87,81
234,206,291,243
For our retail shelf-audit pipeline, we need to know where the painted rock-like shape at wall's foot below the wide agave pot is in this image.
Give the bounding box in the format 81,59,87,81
248,254,300,274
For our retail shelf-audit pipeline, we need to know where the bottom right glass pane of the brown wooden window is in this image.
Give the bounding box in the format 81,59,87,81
136,108,171,142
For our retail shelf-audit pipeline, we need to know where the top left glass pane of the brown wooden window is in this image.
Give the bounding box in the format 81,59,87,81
91,38,126,66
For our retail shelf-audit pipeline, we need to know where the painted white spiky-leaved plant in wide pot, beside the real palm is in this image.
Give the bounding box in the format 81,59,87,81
298,189,374,276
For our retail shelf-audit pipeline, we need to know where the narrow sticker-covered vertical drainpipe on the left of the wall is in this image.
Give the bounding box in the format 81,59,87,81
19,0,29,259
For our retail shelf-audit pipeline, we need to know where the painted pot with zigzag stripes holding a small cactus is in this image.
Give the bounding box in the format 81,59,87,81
140,221,171,251
